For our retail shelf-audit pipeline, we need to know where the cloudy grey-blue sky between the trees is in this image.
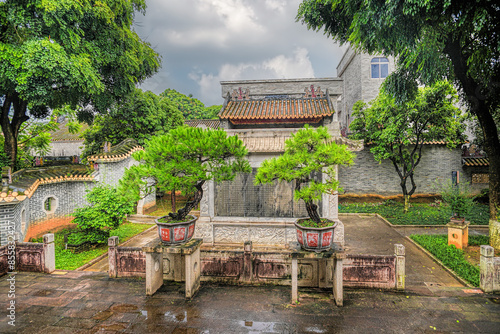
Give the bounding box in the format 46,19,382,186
134,0,345,106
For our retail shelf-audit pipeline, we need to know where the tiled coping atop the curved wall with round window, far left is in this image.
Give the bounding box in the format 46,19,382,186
0,165,94,204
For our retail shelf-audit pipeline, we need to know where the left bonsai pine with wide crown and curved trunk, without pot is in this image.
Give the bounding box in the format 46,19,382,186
120,126,251,221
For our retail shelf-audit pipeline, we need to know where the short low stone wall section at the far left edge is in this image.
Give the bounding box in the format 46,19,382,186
0,234,56,275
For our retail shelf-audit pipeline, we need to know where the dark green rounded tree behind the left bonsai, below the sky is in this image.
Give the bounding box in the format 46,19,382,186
83,88,184,156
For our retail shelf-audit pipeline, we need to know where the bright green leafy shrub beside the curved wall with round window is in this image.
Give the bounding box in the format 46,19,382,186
72,184,134,244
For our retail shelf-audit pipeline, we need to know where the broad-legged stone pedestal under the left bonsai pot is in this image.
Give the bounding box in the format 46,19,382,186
143,239,203,298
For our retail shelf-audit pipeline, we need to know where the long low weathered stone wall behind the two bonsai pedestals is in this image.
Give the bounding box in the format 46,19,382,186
108,237,405,289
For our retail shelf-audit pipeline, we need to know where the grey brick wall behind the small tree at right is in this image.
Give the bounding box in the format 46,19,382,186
339,145,471,195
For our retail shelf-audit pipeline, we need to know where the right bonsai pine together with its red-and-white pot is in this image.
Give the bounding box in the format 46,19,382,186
255,125,354,251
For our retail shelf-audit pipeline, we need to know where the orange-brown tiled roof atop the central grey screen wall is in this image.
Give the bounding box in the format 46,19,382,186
219,97,334,124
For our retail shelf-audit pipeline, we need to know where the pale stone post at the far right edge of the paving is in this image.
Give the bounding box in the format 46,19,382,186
479,245,500,292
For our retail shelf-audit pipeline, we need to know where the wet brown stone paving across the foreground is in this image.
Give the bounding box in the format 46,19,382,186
0,272,500,333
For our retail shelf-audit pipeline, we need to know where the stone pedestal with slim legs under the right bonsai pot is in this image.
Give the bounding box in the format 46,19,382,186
291,243,346,306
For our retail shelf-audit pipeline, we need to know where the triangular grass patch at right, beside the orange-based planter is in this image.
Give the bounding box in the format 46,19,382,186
410,234,496,287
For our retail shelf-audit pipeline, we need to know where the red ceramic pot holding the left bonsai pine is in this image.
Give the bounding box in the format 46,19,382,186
155,216,198,246
